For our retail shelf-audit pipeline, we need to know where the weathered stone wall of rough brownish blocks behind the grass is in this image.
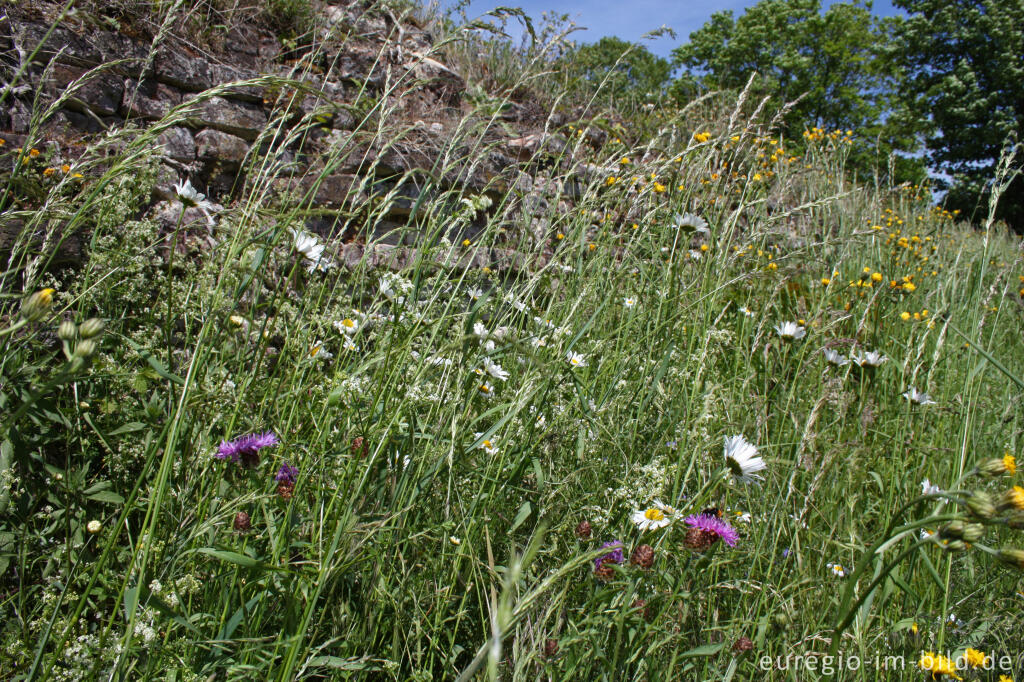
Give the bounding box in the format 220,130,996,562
0,1,585,270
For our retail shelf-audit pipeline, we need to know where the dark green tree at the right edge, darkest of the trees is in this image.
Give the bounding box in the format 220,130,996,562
894,0,1024,231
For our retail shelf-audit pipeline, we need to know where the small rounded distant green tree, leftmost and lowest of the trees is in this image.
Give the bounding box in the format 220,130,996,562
566,36,672,100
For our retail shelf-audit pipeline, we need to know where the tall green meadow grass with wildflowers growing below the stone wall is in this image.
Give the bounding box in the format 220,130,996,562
0,2,1024,680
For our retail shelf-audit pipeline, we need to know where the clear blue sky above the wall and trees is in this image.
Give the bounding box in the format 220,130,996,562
442,0,899,56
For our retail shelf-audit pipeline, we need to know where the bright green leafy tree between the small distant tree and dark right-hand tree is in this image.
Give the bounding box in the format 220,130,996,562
673,0,923,180
